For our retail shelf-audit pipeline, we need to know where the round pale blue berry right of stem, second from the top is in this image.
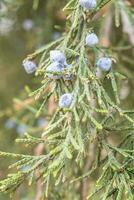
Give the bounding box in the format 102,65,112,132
86,33,99,47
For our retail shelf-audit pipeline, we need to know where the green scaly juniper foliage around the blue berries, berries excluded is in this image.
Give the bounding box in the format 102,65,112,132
0,0,134,200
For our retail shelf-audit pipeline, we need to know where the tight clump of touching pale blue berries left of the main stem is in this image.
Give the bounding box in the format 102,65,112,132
46,50,72,80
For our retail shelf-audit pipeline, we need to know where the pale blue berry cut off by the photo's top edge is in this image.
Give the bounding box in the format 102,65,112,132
80,0,97,10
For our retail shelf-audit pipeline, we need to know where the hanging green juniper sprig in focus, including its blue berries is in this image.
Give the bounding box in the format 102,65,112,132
0,0,134,200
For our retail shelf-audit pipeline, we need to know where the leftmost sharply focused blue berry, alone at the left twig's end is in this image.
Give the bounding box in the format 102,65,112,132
23,60,37,74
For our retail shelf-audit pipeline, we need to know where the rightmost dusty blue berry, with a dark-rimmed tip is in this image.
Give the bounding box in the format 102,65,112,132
97,57,112,71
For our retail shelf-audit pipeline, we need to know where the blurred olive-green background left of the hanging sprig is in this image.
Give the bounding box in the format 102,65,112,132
0,0,65,200
